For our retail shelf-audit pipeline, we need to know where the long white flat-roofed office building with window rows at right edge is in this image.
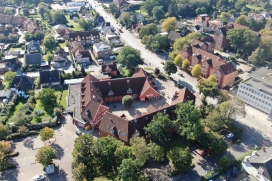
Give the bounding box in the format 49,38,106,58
237,67,272,120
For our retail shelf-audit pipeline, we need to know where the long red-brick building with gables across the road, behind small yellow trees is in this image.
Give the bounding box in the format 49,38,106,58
180,45,237,88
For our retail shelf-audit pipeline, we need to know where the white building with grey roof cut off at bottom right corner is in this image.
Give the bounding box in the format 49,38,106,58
242,147,272,181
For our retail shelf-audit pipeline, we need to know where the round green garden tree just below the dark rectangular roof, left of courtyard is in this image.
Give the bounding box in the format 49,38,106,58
38,88,57,107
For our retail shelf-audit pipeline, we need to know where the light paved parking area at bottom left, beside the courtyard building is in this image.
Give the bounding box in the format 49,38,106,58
0,117,76,181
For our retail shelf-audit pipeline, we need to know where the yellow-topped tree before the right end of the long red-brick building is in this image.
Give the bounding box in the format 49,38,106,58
197,75,219,98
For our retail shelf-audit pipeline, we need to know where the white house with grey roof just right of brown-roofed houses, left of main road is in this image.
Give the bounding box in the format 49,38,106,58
93,42,112,58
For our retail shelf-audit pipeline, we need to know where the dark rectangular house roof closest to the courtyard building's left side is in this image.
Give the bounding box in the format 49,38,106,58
39,70,60,84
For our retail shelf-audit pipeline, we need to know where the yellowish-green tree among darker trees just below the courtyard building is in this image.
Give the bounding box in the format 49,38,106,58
130,136,148,166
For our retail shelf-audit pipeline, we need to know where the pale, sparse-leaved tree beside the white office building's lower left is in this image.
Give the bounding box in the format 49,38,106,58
220,98,246,120
